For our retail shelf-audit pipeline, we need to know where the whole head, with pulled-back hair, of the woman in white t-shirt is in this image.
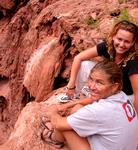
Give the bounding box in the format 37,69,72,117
88,59,122,100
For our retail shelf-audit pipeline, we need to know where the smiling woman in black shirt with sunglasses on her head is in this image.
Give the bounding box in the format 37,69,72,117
66,20,138,112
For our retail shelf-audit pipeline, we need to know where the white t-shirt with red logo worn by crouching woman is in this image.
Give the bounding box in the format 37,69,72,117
67,92,138,150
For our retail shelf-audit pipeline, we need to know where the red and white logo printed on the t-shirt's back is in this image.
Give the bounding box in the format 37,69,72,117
122,100,136,122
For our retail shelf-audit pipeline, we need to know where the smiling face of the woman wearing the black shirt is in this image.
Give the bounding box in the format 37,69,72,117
113,29,133,55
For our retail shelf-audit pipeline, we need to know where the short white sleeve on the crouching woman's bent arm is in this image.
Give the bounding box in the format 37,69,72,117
67,105,99,137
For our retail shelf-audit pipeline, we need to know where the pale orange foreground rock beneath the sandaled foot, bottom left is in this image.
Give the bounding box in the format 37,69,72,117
0,95,68,150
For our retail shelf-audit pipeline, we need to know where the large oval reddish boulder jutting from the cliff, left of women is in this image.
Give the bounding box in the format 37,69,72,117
23,33,71,101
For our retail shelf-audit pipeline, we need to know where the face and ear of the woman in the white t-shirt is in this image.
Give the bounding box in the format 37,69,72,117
88,70,118,100
